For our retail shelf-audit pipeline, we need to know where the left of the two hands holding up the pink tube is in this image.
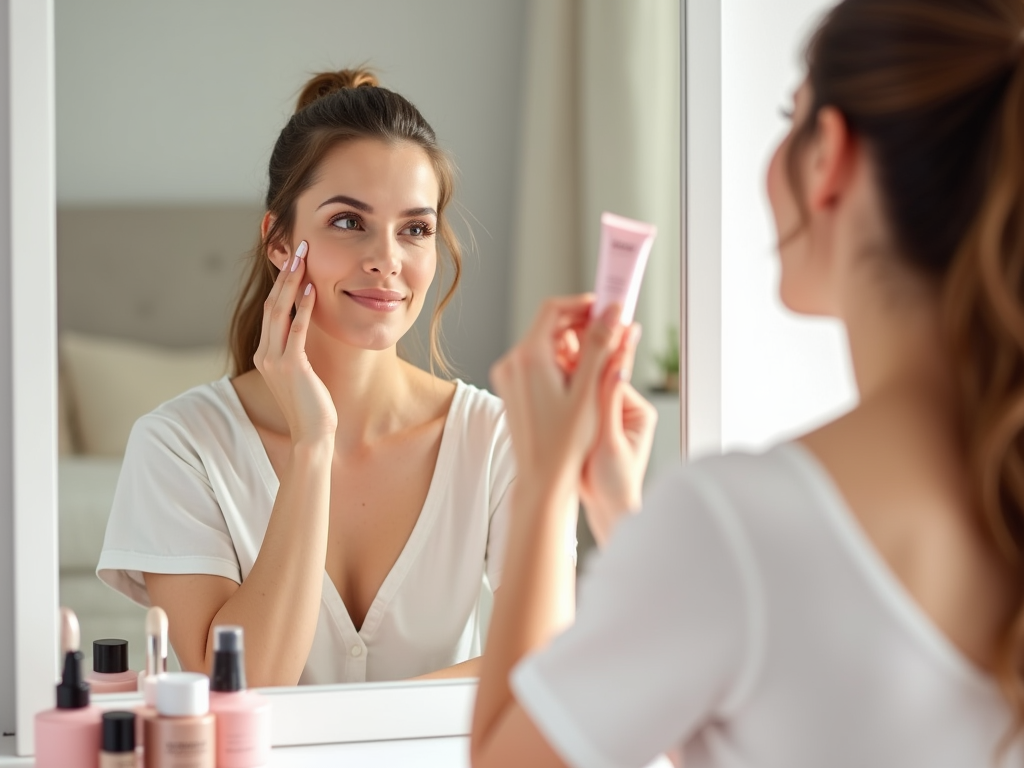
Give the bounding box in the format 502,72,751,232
490,296,623,492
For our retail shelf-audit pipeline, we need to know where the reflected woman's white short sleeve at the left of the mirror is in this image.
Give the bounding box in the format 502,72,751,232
96,414,242,606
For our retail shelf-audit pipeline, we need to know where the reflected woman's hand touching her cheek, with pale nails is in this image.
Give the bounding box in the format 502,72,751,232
253,241,338,444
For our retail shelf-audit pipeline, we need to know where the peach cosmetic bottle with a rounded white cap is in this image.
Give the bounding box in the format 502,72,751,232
143,672,216,768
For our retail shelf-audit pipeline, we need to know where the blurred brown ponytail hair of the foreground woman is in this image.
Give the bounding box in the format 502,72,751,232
787,0,1024,741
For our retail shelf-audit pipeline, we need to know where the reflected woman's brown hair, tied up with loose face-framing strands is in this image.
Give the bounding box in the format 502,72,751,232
228,69,462,375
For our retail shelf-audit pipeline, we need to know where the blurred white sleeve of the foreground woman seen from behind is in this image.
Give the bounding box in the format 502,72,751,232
511,469,758,768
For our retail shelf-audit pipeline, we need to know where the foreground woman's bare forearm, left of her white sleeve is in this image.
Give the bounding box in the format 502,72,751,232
471,472,575,765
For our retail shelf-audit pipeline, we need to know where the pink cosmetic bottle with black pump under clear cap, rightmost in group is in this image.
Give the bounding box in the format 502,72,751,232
210,627,270,768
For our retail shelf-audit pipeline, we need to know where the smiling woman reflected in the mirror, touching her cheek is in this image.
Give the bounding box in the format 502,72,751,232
97,71,574,686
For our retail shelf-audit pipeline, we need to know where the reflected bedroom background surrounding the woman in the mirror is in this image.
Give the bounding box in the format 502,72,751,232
54,0,681,692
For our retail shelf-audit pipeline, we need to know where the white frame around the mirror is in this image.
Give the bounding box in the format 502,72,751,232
9,0,722,756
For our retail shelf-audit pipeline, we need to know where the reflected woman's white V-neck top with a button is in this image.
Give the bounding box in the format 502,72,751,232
96,377,515,684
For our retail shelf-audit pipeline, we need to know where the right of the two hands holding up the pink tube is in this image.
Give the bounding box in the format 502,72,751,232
580,326,657,546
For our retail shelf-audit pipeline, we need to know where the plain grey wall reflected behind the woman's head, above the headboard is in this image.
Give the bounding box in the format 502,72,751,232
55,0,526,383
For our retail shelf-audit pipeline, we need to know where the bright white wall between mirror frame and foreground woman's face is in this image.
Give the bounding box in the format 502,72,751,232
721,0,855,450
